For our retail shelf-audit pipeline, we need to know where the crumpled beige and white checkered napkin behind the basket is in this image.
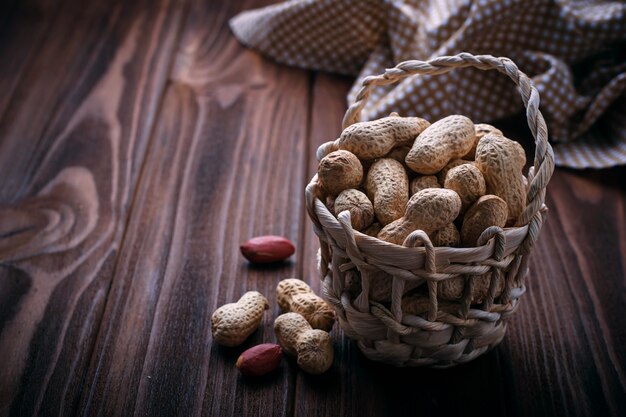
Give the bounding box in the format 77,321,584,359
230,0,626,168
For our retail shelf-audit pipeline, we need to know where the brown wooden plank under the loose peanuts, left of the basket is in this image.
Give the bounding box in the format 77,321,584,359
80,1,309,416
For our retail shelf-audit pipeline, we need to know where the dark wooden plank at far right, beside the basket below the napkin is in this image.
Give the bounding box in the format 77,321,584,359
509,168,626,416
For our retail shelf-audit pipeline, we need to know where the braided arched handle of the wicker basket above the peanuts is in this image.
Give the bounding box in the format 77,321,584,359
342,52,554,225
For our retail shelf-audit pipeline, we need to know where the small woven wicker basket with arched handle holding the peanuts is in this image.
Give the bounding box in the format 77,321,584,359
306,53,554,367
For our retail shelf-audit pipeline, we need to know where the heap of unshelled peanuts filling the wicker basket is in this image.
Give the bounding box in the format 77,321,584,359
318,113,526,247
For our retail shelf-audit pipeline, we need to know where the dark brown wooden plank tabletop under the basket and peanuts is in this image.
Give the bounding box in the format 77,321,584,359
0,0,626,416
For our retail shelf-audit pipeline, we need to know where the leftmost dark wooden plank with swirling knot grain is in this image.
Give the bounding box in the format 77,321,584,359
0,1,181,415
